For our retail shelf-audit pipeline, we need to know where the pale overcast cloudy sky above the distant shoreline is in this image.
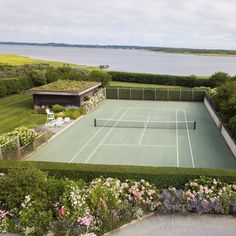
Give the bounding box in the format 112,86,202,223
0,0,236,49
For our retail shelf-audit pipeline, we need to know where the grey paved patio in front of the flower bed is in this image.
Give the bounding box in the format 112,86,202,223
107,214,236,236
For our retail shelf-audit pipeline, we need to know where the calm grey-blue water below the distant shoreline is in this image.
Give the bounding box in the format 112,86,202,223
0,45,236,75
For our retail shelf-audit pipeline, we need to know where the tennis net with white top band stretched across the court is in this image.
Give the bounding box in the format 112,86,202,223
94,118,196,129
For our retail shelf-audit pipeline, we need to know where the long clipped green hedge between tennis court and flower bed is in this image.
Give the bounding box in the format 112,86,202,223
0,161,236,188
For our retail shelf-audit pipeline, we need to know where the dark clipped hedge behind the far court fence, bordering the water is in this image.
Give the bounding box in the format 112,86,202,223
108,71,213,87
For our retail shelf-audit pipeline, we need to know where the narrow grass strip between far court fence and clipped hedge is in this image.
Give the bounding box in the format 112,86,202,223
109,81,192,89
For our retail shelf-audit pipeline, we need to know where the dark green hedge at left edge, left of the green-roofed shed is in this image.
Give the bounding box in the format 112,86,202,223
0,77,33,97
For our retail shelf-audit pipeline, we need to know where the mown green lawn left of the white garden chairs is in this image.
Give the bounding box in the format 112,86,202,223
0,94,46,133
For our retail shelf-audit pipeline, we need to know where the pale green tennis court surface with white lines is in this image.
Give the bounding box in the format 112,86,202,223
28,100,236,169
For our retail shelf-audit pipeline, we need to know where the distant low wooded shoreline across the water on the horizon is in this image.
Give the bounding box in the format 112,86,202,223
0,42,236,56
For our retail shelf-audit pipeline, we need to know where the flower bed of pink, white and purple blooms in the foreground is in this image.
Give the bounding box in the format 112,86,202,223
0,167,236,235
